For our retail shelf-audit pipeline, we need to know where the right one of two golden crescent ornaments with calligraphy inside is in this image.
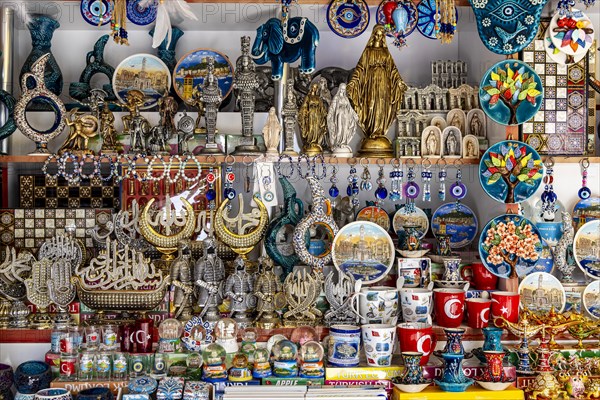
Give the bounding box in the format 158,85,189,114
214,195,269,261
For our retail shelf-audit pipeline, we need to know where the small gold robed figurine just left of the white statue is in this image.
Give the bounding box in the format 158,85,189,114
298,83,327,156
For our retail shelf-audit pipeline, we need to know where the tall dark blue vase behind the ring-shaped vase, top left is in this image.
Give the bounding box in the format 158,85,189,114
19,15,63,96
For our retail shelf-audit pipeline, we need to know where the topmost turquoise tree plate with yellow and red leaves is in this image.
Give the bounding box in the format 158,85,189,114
479,60,544,125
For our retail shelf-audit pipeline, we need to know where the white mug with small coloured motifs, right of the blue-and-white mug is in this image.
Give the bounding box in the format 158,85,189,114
361,324,396,367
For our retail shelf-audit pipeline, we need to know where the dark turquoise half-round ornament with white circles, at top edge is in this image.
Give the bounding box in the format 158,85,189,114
469,0,548,55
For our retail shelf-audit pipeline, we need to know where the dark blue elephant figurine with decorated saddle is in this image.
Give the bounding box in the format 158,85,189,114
252,17,319,80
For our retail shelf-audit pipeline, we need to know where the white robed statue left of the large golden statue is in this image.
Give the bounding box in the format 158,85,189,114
327,83,358,157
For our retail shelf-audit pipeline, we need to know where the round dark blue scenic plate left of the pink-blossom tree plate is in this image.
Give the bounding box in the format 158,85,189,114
431,203,478,249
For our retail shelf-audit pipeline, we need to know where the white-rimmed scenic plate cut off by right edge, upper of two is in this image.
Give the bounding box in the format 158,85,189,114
573,220,600,279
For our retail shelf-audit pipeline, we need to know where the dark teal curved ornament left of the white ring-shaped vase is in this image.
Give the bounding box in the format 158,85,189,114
265,176,304,279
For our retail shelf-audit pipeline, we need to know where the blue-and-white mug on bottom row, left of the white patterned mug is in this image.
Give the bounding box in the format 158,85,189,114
327,325,360,367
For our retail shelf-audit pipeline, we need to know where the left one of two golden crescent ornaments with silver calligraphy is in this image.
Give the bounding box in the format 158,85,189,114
139,198,196,261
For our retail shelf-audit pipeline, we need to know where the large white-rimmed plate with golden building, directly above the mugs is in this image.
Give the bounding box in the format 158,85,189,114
331,221,395,284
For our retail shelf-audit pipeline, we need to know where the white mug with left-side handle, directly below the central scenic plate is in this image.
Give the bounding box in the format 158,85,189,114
351,286,398,325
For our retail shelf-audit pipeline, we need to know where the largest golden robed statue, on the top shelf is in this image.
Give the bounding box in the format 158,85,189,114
346,25,407,157
